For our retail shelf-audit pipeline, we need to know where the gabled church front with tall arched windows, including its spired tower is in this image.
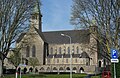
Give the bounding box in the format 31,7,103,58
20,3,44,65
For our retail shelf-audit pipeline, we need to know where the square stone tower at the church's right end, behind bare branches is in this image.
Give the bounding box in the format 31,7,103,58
89,25,98,66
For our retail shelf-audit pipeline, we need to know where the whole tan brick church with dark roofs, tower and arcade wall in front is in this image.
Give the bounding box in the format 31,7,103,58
4,4,108,73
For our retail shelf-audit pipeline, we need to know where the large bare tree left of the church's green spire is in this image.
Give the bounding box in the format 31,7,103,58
0,0,41,76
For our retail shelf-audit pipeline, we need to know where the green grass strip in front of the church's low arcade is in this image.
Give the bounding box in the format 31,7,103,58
3,74,87,78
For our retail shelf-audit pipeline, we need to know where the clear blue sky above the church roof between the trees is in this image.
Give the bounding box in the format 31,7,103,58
41,0,74,31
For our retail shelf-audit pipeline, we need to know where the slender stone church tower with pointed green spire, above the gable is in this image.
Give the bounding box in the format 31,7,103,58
30,3,42,32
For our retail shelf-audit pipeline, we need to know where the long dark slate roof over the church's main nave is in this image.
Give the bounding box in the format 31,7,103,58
43,30,90,44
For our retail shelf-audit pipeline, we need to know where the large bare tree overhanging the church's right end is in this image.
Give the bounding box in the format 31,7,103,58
70,0,120,59
